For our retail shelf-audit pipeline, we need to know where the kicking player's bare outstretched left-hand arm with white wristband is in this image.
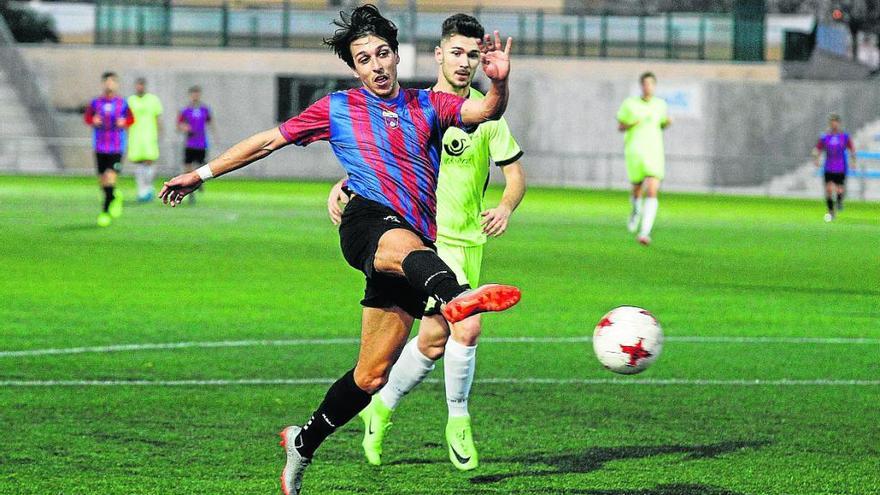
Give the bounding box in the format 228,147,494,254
159,127,288,206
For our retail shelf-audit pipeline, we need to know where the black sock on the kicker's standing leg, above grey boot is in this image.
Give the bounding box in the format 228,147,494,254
294,369,370,457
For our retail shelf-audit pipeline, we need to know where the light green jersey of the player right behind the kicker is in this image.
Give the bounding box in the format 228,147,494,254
437,88,522,246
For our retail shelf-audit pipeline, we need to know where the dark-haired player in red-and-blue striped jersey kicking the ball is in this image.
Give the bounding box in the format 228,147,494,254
160,4,520,495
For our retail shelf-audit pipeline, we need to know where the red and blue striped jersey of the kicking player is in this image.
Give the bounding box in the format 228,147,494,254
279,88,476,240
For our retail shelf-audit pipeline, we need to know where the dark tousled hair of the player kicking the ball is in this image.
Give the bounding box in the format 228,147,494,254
324,3,398,69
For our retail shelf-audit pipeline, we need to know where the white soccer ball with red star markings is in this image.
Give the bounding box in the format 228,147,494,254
593,306,663,375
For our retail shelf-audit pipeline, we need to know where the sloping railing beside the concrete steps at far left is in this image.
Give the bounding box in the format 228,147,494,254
0,16,63,167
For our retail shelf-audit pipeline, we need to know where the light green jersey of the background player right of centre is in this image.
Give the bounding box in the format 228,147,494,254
617,96,667,167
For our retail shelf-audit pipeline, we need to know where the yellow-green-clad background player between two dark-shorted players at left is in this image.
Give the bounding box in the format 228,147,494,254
127,77,163,203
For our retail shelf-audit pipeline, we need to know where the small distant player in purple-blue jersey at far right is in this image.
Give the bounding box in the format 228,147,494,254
813,114,856,222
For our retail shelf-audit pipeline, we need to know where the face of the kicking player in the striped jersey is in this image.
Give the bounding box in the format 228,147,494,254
350,35,400,98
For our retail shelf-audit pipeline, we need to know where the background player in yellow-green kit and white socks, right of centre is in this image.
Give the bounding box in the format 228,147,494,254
617,72,672,246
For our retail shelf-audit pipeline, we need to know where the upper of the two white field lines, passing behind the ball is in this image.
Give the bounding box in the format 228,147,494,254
0,335,880,358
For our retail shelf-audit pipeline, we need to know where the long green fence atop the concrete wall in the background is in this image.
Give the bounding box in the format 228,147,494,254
95,0,763,60
